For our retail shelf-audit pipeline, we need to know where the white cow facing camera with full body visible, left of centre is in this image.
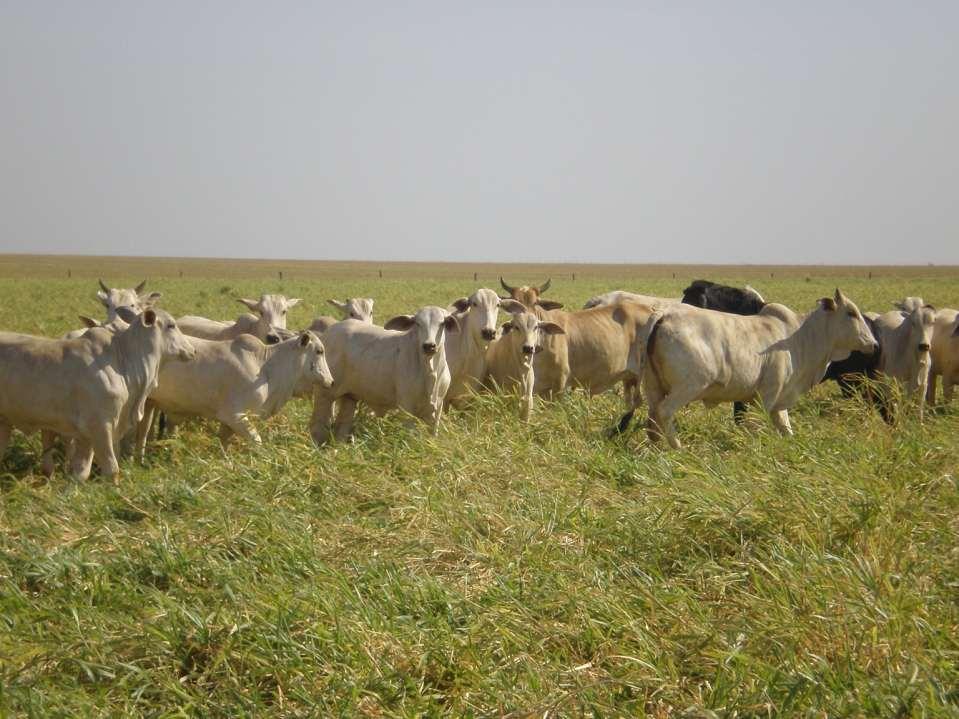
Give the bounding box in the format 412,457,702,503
310,307,459,445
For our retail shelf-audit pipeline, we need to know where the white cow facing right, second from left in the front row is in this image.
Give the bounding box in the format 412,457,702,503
137,332,333,460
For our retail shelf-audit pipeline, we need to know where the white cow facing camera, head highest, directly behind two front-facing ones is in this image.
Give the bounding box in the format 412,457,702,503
446,289,524,405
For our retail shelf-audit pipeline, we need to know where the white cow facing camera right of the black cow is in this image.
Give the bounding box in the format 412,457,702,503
866,297,936,422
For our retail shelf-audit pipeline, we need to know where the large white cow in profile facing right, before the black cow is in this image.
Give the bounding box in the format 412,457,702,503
621,289,876,449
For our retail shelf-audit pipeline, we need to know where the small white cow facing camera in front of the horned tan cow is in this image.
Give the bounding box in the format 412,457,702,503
487,310,565,422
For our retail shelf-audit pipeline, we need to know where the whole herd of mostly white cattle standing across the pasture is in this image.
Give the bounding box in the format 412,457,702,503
0,278,959,479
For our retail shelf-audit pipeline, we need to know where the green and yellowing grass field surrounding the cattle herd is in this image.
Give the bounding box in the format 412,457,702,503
0,257,959,717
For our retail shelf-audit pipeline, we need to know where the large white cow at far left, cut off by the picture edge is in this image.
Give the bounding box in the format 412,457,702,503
0,309,196,479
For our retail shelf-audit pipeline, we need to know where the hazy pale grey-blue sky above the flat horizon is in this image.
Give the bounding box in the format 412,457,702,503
0,0,959,264
